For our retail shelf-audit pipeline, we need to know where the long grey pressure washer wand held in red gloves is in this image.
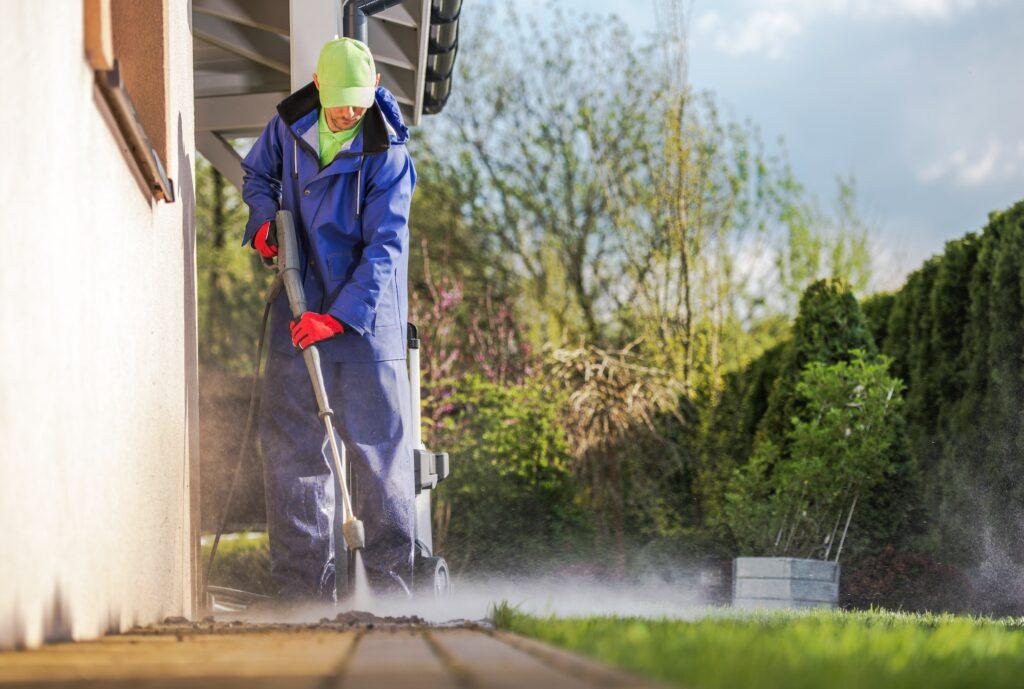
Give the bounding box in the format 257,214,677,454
276,206,367,551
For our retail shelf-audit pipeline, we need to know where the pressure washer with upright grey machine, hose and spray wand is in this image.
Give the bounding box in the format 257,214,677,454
205,211,452,611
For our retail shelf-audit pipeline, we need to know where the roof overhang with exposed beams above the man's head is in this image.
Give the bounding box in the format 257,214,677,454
191,0,462,185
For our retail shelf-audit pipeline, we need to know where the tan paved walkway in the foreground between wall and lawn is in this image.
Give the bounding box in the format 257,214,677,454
0,622,653,689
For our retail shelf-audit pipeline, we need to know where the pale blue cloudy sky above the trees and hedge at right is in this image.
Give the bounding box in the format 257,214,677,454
528,0,1024,287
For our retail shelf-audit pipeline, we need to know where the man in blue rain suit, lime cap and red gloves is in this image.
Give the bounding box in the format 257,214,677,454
242,38,416,600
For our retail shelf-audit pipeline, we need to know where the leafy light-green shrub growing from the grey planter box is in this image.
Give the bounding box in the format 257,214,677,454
726,350,906,557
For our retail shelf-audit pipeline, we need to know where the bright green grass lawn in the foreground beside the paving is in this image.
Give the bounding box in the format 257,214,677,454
493,603,1024,689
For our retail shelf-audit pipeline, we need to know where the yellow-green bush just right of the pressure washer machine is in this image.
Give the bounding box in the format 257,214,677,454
432,376,592,573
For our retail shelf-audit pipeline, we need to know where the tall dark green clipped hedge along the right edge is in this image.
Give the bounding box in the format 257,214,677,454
714,203,1024,611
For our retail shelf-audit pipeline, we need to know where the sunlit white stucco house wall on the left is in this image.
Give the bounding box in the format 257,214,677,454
0,0,195,648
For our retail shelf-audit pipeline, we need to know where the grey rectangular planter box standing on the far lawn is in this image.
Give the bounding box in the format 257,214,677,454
732,557,840,609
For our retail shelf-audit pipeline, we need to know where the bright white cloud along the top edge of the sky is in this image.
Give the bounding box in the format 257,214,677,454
693,0,1008,59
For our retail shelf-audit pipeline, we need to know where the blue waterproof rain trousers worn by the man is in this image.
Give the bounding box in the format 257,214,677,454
260,353,416,600
